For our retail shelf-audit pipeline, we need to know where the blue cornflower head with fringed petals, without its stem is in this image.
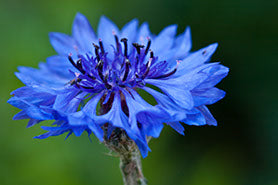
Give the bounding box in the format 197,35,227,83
8,13,228,157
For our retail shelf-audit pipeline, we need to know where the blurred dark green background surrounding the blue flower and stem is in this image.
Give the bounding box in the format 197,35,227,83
0,0,278,185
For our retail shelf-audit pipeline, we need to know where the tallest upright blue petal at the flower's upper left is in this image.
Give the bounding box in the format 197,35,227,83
72,13,97,53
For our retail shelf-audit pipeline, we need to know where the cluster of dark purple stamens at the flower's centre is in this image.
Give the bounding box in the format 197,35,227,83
68,34,177,93
